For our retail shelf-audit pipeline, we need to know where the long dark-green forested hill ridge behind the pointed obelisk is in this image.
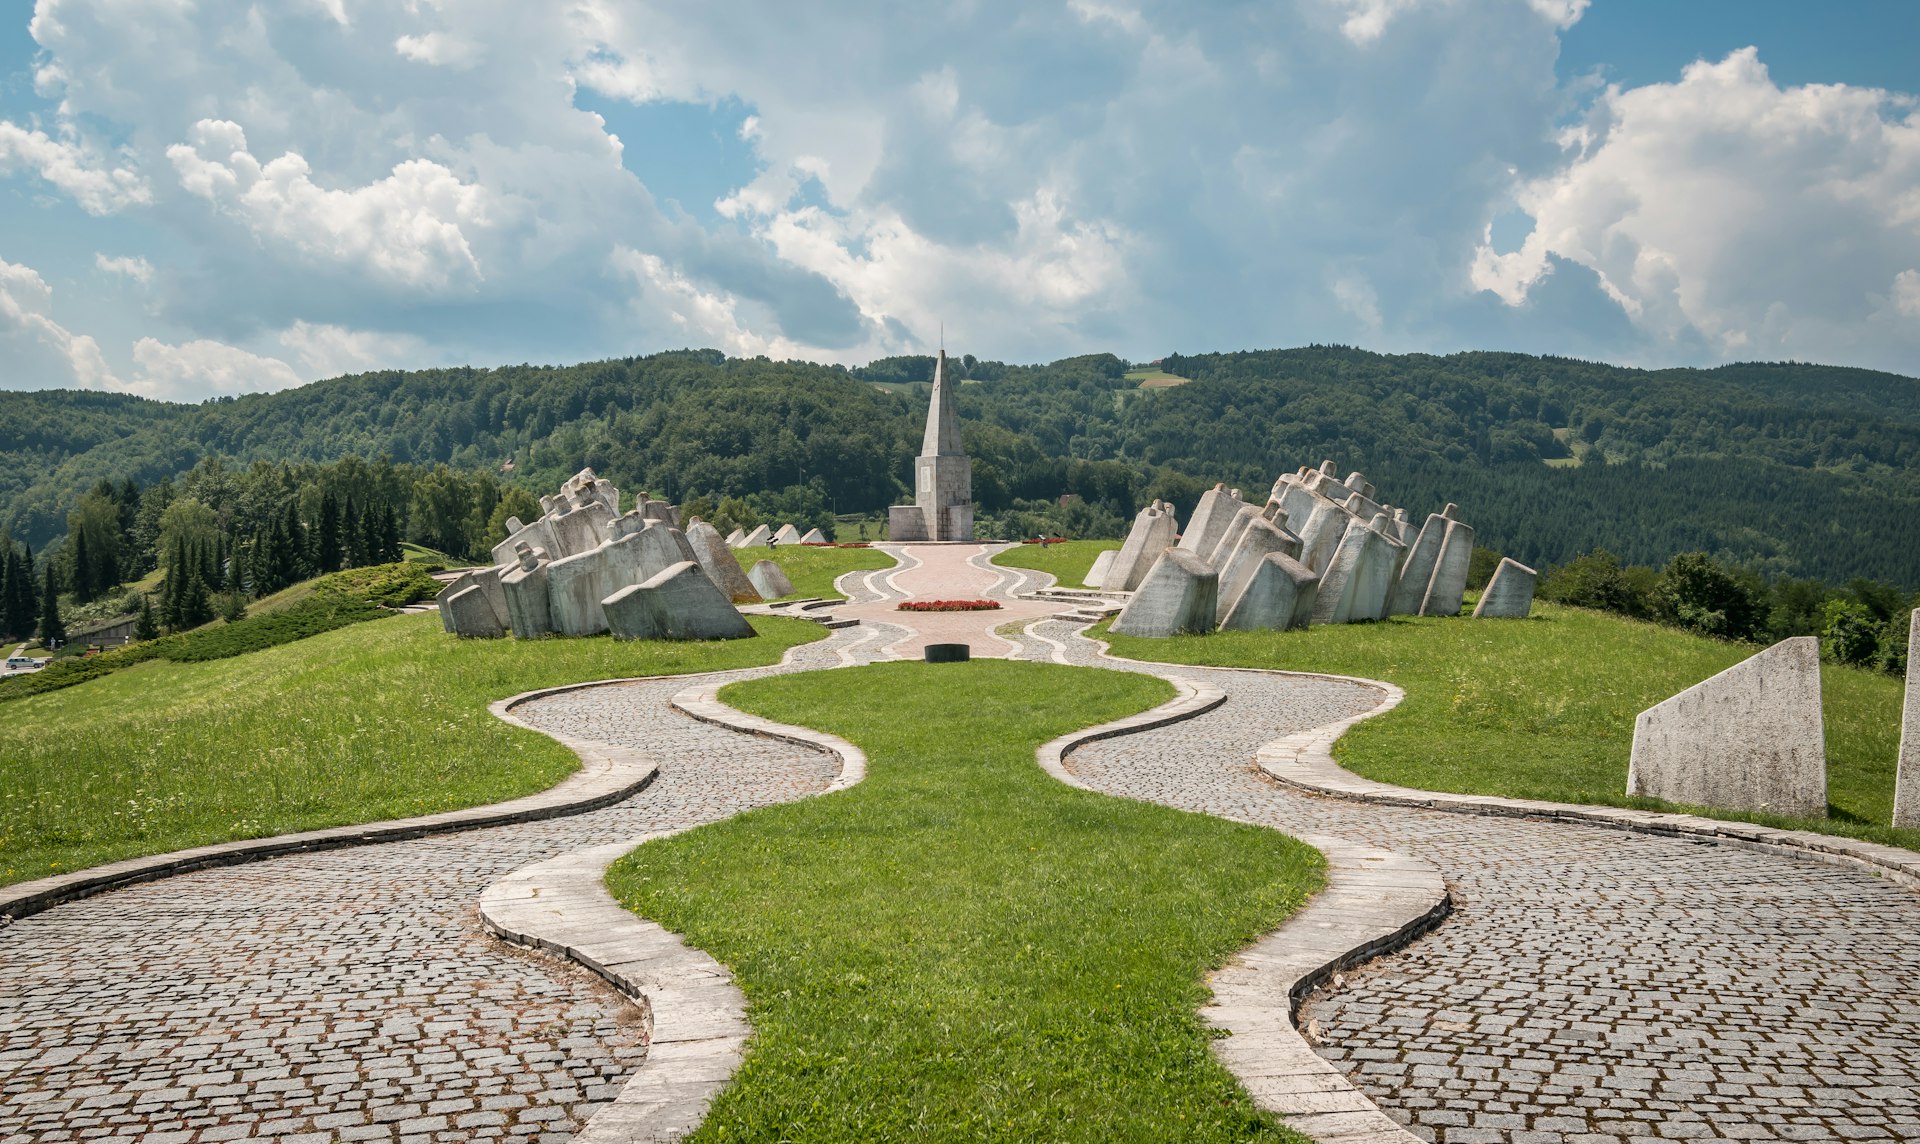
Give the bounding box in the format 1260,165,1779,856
0,346,1920,587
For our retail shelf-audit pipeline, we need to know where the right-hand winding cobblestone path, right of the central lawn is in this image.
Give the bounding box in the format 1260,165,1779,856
1041,624,1920,1144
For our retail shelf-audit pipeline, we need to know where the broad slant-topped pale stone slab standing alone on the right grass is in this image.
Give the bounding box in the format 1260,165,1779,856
1626,635,1826,818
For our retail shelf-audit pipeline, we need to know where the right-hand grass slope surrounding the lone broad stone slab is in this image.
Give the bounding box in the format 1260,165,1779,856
1100,601,1920,848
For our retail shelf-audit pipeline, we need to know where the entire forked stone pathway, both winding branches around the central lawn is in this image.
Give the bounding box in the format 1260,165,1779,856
0,547,1920,1144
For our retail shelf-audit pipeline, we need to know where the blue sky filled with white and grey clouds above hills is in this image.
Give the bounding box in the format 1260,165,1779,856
0,0,1920,401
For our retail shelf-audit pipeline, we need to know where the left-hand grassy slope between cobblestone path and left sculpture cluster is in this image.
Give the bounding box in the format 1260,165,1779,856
0,614,826,883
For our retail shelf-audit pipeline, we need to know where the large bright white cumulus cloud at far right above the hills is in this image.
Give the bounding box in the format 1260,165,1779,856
1469,48,1920,363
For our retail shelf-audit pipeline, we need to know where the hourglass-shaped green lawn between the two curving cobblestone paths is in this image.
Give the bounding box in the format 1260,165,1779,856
609,660,1321,1142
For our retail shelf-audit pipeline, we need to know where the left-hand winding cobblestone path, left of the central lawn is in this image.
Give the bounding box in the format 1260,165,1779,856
0,628,883,1144
